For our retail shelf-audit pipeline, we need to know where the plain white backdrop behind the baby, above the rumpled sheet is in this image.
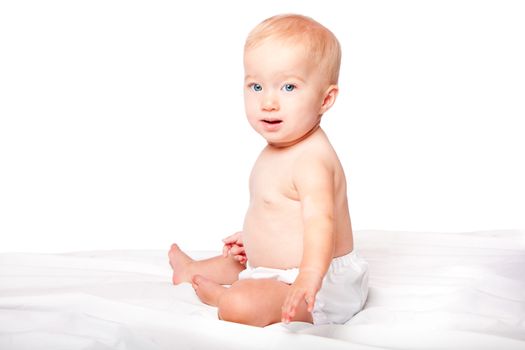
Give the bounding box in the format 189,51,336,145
0,0,525,252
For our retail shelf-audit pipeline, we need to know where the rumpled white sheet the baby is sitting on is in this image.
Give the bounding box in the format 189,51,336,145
0,231,525,350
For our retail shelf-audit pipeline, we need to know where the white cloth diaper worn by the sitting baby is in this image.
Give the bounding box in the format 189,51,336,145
239,251,368,325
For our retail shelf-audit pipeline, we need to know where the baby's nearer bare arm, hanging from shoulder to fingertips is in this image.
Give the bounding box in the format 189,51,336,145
282,158,335,323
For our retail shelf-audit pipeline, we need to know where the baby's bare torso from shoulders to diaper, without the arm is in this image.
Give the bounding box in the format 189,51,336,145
243,128,353,269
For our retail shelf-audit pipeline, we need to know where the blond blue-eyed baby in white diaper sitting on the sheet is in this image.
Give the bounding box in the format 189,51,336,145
169,15,368,326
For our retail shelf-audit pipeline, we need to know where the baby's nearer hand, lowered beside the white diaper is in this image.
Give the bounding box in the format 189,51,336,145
281,273,322,323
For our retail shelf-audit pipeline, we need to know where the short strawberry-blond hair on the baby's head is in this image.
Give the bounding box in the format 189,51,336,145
244,14,341,84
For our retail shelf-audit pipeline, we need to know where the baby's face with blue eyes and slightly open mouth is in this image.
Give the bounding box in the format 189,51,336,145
244,40,328,146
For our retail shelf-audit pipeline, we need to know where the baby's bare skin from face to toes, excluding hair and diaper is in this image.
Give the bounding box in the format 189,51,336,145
169,26,353,326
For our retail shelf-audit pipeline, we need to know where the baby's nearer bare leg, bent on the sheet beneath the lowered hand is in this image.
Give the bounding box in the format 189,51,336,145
193,276,313,327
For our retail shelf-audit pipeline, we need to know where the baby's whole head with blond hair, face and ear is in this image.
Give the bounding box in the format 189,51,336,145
244,15,341,147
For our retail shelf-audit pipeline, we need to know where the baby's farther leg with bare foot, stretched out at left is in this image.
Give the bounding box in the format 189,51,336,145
168,244,244,284
